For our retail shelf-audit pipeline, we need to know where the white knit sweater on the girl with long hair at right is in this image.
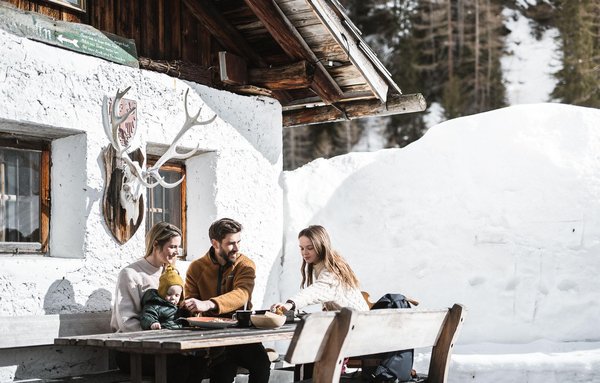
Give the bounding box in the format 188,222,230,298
289,262,369,311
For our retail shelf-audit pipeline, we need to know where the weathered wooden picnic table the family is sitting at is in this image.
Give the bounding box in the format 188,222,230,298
54,323,296,383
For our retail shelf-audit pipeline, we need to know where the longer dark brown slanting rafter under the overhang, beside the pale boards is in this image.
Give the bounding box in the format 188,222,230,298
239,0,343,104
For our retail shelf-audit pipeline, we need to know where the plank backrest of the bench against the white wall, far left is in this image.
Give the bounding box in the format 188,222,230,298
0,311,112,349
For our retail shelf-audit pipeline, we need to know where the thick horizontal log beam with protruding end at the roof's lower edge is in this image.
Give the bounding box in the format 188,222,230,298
283,93,427,128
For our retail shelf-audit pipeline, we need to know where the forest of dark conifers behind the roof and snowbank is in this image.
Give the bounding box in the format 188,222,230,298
283,0,600,170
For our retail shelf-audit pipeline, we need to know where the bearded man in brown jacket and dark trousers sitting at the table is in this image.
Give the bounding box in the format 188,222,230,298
185,218,271,383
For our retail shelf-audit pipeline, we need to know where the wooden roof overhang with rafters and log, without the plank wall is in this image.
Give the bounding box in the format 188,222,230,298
200,0,426,126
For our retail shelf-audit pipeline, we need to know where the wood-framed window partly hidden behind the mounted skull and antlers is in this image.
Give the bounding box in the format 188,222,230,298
146,157,186,259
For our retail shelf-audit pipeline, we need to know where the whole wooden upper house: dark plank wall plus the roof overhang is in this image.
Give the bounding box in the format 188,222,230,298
0,0,426,127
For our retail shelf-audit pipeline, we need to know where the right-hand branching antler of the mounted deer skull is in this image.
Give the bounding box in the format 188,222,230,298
144,89,217,188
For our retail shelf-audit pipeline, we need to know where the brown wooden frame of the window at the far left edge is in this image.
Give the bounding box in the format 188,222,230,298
0,135,52,255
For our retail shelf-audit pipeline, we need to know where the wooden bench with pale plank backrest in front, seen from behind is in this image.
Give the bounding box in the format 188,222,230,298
285,304,465,383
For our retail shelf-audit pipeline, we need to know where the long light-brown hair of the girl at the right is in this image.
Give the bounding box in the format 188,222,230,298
298,225,359,288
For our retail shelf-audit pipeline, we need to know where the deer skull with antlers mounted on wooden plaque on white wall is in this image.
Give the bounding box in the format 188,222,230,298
102,87,217,244
